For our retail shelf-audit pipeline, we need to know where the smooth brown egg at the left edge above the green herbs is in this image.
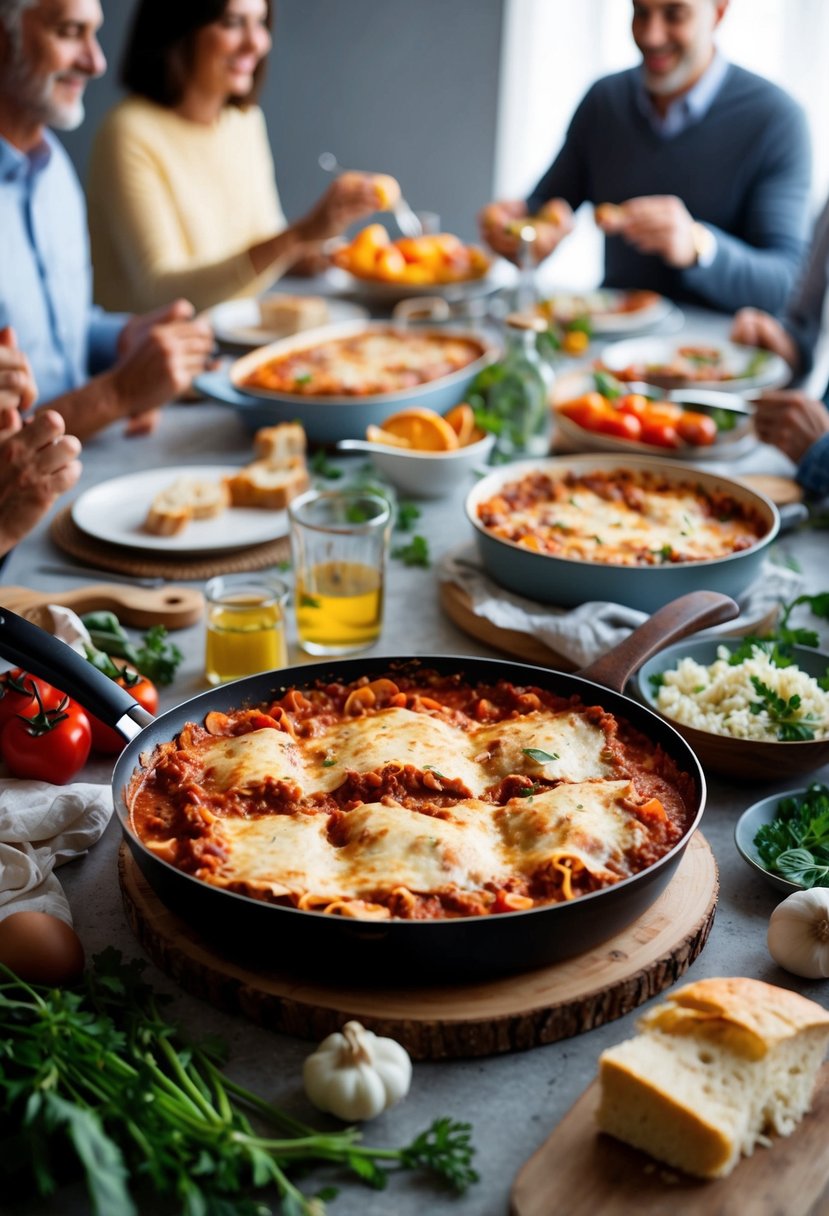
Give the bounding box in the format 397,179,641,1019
0,912,84,987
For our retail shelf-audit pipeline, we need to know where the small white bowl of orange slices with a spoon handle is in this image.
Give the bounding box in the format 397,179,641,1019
337,401,495,499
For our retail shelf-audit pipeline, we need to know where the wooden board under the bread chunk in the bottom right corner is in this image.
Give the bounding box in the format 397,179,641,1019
509,1064,829,1216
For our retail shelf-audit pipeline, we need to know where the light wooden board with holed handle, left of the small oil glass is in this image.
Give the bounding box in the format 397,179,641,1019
0,582,204,632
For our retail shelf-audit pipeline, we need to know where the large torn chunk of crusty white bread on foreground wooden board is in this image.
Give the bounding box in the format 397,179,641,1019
598,978,829,1178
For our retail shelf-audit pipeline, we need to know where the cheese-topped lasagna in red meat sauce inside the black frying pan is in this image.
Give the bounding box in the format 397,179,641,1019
129,671,695,919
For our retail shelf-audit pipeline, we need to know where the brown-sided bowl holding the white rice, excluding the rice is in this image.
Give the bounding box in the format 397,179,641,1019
635,637,829,781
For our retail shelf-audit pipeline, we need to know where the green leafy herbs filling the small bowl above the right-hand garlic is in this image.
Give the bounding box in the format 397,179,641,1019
754,782,829,886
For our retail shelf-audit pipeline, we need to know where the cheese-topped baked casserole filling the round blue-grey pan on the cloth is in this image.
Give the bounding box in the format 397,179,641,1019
476,468,768,565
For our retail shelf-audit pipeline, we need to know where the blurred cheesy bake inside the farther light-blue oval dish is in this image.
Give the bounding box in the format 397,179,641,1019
241,328,485,396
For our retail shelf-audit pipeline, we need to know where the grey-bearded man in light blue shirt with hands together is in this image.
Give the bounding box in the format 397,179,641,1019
0,0,213,439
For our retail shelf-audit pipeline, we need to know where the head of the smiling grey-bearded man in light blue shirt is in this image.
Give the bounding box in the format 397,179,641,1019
0,0,107,137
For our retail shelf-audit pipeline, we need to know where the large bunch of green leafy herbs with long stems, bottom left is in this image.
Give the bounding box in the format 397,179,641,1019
0,948,478,1216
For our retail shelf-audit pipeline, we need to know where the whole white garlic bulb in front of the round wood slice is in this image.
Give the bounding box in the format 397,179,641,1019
303,1021,412,1122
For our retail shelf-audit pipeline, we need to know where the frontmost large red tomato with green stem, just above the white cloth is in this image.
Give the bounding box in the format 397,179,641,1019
0,697,92,786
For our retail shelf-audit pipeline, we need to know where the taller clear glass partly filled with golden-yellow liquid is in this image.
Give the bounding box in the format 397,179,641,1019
288,489,391,654
